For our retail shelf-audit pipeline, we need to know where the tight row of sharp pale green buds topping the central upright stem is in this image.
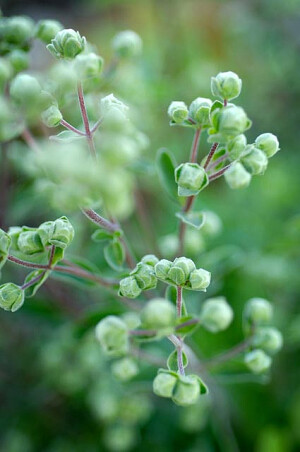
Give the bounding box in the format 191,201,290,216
154,257,211,292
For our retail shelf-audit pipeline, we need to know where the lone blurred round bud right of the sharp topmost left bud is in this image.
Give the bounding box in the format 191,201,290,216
112,30,143,58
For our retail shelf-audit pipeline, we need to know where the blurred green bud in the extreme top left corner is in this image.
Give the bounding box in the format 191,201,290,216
3,16,34,45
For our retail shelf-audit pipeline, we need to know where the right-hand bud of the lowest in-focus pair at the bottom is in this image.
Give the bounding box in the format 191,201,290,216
172,375,200,406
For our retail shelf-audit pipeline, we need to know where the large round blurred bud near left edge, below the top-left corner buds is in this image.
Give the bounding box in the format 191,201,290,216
10,74,42,106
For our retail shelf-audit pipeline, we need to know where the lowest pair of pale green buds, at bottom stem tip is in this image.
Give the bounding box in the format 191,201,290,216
153,369,208,406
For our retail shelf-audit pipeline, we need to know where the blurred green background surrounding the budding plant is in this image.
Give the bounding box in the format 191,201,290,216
0,0,300,452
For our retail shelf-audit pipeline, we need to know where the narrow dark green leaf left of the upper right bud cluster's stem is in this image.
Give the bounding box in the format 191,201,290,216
156,149,178,202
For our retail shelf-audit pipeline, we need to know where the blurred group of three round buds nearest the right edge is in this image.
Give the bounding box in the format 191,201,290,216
244,298,283,374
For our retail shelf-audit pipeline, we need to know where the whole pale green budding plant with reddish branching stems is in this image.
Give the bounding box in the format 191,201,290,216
0,16,282,406
